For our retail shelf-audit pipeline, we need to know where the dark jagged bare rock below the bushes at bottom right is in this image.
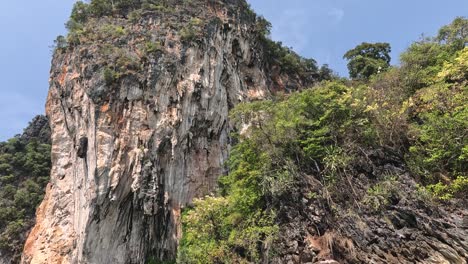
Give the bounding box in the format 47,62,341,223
272,152,468,264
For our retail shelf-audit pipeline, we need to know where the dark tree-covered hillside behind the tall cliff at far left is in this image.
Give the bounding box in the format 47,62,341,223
0,116,51,262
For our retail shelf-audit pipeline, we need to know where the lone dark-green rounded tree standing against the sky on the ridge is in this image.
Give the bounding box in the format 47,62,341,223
343,42,391,79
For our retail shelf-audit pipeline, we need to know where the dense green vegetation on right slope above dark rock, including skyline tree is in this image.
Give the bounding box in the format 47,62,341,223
179,18,468,263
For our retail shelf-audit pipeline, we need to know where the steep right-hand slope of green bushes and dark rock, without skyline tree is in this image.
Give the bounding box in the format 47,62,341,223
178,40,468,264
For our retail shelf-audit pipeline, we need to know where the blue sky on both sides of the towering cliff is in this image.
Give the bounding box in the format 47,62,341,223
0,0,468,141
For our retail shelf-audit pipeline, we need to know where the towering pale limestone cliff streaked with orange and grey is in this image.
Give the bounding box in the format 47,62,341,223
22,1,310,263
